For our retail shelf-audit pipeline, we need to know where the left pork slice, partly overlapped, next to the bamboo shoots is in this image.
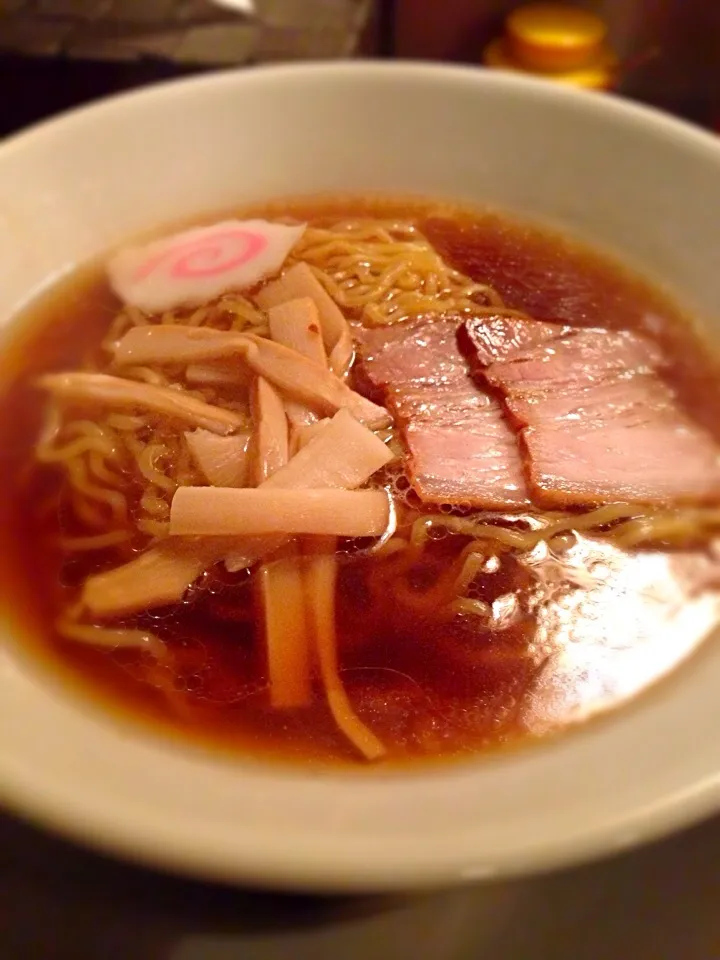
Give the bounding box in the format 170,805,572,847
358,318,529,509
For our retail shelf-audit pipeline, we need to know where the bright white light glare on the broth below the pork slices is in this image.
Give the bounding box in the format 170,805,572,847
521,537,720,734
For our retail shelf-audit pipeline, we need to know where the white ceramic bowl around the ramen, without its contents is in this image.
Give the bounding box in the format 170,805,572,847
0,63,720,891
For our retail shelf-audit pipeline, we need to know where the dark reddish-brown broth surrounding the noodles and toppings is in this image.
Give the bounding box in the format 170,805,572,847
0,200,720,762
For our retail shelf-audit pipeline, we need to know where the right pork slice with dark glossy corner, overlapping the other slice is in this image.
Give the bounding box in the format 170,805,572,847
461,318,720,506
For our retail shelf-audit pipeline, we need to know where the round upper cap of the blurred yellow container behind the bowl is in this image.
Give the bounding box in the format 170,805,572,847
505,3,607,73
